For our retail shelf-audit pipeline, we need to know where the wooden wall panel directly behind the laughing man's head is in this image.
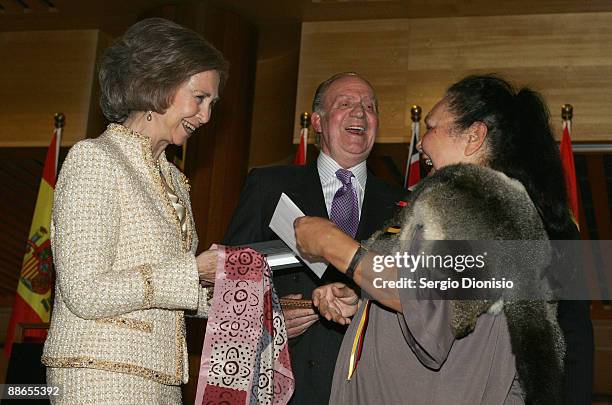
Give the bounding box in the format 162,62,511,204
294,20,410,143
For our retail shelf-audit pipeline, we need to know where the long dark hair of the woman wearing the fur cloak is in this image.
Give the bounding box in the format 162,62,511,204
444,75,575,239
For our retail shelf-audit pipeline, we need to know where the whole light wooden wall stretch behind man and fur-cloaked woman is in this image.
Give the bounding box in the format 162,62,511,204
294,12,612,143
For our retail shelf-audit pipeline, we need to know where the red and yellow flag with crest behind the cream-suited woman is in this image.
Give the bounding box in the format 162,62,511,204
4,128,62,356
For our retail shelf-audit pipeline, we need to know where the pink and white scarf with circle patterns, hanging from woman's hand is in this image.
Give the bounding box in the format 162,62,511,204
195,246,294,405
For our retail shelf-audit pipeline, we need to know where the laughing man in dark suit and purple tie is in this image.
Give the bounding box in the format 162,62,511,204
224,73,404,405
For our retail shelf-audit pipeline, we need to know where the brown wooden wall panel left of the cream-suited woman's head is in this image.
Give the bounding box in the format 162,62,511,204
0,30,108,147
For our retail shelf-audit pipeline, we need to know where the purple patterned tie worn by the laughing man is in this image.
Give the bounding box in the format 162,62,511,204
329,169,359,238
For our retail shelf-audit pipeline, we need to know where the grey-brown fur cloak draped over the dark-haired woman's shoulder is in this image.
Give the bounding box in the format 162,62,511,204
370,164,565,405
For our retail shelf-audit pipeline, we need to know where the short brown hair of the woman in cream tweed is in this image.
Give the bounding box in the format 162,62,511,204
98,18,228,122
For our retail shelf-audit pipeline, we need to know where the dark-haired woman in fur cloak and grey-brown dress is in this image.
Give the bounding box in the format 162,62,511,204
295,76,584,404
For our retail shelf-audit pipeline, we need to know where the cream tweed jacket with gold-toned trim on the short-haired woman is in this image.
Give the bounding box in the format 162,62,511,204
42,124,210,385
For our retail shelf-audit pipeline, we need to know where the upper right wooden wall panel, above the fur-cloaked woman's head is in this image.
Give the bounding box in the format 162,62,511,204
408,13,612,70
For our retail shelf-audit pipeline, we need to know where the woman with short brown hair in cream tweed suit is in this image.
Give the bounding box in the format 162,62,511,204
42,18,228,404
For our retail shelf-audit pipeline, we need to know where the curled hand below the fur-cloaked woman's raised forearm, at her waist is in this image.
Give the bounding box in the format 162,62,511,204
312,283,359,325
